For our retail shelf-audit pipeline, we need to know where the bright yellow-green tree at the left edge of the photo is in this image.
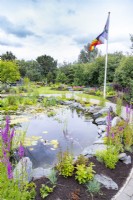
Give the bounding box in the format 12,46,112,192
0,60,20,83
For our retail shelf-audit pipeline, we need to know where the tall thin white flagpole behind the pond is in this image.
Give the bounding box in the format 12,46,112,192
103,12,110,99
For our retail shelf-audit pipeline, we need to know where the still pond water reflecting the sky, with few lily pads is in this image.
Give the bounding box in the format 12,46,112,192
21,107,97,168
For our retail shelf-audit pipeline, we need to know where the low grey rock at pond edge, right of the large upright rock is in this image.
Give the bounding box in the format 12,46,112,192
32,167,52,180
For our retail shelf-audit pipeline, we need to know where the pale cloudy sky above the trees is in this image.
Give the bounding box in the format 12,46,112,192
0,0,133,63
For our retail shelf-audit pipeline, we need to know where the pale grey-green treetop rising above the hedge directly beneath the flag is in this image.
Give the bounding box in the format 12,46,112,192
78,43,98,63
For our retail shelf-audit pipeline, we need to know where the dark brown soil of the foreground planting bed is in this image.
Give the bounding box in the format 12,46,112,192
34,153,133,200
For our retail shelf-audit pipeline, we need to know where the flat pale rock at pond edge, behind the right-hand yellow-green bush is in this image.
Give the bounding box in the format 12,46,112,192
81,144,107,156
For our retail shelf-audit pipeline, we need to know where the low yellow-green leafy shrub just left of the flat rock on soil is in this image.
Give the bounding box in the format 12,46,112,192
75,162,95,184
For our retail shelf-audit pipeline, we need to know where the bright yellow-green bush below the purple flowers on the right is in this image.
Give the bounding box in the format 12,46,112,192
96,147,119,169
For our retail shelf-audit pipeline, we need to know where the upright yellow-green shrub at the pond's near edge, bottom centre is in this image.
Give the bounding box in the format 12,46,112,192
56,151,74,177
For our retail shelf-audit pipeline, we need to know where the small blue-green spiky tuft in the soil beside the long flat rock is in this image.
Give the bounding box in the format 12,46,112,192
86,179,101,194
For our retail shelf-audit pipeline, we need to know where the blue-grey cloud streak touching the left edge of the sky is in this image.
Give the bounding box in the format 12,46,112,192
0,16,34,38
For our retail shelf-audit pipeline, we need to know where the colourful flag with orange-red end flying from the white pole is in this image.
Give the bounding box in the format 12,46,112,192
89,13,109,51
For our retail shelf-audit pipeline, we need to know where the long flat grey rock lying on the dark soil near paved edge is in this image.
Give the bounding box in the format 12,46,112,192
94,174,118,190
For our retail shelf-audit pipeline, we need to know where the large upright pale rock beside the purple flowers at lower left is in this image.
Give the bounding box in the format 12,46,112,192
13,157,32,182
